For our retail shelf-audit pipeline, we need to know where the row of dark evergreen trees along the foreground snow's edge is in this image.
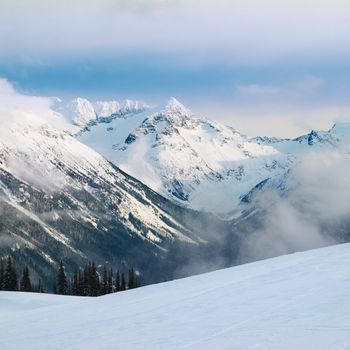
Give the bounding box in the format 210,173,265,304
0,257,141,296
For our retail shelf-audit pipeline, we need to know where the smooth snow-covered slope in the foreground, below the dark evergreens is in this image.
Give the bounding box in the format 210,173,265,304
0,244,350,350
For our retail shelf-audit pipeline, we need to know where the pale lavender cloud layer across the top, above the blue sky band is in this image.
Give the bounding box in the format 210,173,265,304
0,0,350,64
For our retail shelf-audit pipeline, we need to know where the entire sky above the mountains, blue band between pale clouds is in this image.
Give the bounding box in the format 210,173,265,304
0,0,350,137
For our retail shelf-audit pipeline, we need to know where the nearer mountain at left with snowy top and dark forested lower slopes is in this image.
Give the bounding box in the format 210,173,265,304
0,115,230,288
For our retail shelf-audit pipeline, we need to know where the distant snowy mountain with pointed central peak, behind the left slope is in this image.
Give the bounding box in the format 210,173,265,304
67,98,349,217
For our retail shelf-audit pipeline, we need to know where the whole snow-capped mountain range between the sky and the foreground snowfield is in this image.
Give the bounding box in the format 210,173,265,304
0,98,350,286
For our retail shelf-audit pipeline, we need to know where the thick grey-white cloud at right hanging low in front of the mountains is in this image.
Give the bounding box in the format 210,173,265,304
241,146,350,261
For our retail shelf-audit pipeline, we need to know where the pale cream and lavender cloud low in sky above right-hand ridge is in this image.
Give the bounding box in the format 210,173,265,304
193,76,350,138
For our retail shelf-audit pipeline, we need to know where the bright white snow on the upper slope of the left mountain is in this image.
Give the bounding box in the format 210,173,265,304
0,115,197,246
